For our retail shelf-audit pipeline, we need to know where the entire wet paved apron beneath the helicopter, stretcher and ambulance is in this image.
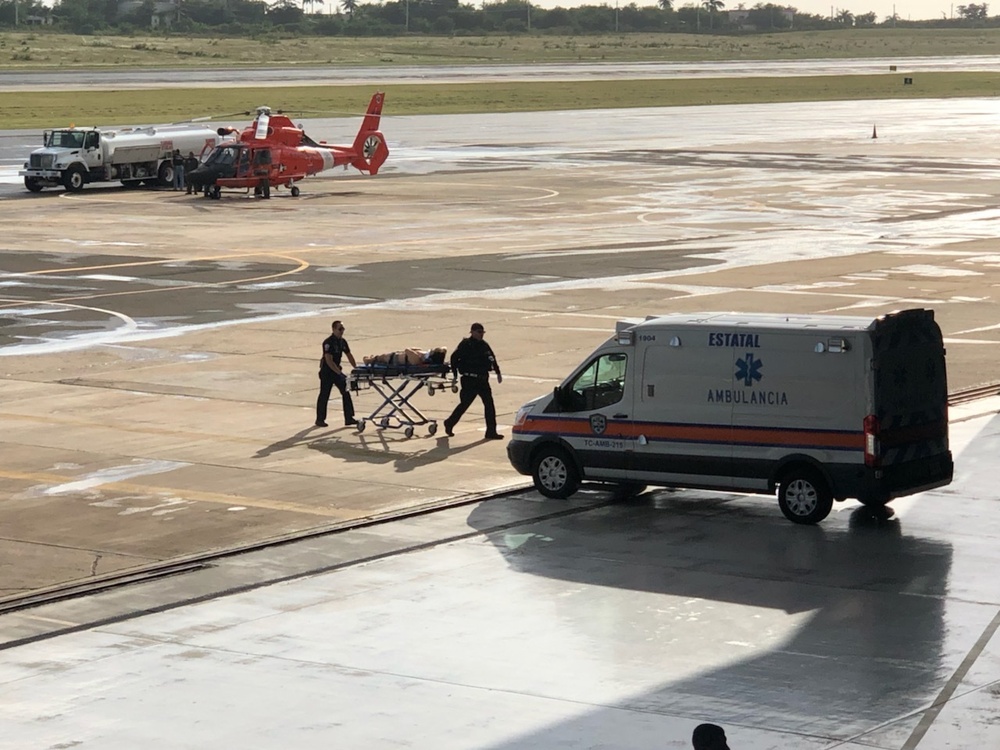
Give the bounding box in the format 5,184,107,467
0,94,1000,750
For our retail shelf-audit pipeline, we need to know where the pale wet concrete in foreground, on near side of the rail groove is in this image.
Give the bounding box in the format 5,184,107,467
0,408,1000,750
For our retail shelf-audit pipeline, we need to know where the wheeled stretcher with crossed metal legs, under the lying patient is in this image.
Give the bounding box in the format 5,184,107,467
349,363,458,438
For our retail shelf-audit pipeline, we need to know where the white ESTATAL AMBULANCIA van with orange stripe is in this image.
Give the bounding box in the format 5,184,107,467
507,310,953,524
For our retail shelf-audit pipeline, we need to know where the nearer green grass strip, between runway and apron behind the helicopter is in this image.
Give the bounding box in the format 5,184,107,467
0,72,1000,130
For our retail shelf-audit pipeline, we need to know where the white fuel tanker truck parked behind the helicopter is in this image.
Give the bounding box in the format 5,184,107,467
20,125,225,193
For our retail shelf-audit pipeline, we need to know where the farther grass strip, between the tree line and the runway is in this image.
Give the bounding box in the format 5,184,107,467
0,27,1000,72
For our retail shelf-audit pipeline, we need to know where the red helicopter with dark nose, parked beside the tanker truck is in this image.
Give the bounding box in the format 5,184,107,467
187,91,389,199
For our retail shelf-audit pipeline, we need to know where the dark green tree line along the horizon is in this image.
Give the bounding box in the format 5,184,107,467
0,0,1000,36
